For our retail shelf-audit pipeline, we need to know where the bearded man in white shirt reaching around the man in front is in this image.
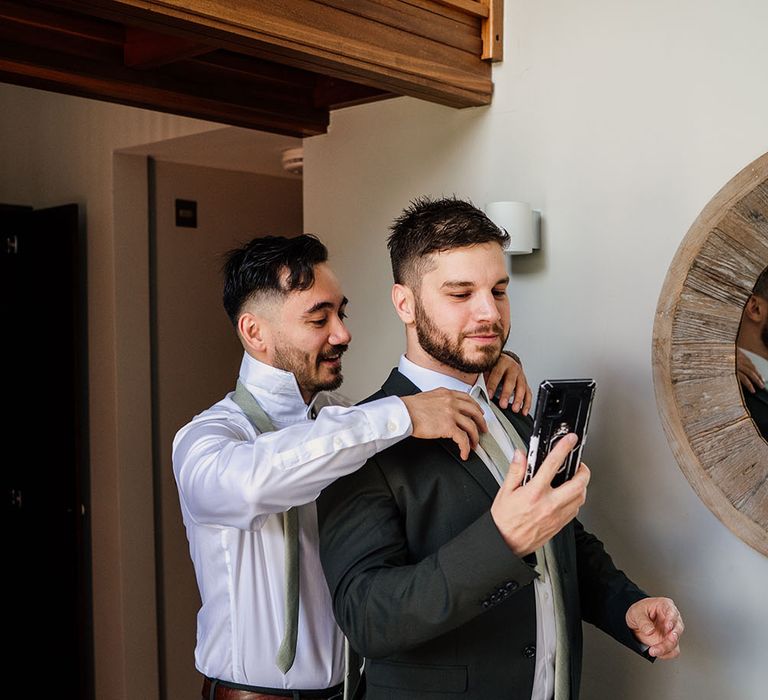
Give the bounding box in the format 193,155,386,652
173,235,530,700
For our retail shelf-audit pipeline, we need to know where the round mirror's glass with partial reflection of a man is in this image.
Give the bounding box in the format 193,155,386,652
736,267,768,440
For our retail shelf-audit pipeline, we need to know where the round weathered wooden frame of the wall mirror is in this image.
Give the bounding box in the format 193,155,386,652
653,153,768,556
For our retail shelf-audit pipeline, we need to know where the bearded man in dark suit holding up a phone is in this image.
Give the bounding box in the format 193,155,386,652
318,199,683,700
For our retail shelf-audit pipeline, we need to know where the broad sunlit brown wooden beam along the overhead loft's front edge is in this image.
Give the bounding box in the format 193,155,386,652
63,0,493,107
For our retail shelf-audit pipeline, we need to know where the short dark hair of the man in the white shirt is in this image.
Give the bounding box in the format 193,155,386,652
222,233,328,327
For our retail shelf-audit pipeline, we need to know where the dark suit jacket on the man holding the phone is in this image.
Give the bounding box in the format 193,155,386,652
318,370,646,700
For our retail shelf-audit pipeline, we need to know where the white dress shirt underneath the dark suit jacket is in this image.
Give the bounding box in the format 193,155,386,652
398,355,557,700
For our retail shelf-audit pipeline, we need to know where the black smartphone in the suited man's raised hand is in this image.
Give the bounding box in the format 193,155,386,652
523,379,596,487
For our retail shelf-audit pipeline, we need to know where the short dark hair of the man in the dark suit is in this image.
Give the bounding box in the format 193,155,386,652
387,197,509,287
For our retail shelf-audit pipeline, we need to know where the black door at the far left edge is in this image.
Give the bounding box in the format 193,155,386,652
0,204,92,698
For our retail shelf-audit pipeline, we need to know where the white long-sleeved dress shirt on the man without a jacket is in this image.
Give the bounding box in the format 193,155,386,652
173,355,411,689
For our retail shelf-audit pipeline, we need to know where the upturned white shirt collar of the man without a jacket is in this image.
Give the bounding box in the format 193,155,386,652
240,353,317,429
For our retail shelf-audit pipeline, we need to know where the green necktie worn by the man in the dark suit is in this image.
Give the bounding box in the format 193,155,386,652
480,393,571,700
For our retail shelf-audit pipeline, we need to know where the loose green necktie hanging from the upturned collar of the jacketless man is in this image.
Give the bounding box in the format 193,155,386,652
232,380,299,674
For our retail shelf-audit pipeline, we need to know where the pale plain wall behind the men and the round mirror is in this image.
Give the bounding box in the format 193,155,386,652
304,0,768,700
